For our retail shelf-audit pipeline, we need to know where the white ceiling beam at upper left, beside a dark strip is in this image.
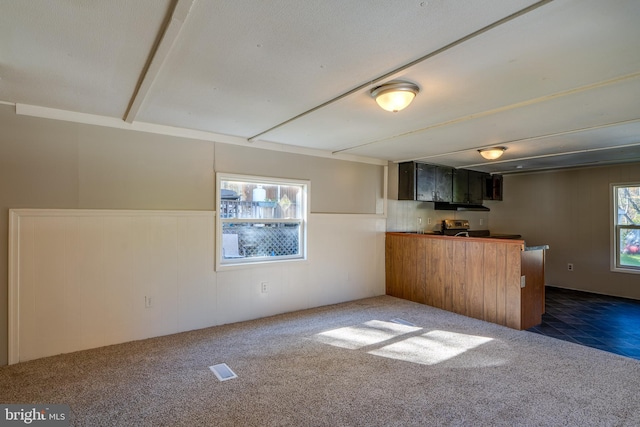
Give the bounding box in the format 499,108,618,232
124,0,196,123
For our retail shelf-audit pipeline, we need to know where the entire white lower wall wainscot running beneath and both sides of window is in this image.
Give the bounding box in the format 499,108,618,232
9,209,384,363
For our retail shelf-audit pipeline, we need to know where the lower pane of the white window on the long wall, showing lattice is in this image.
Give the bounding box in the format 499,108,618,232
222,222,300,261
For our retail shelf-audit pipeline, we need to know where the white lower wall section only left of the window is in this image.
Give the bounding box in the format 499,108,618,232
9,210,216,363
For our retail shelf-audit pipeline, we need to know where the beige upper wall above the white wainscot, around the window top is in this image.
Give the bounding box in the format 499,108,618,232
0,105,384,365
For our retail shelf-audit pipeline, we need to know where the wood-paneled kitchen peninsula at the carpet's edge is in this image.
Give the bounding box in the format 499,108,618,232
385,232,548,329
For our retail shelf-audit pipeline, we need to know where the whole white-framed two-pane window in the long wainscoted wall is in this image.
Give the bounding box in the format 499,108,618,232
216,174,309,267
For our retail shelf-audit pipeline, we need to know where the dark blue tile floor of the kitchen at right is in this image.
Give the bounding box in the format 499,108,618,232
529,286,640,360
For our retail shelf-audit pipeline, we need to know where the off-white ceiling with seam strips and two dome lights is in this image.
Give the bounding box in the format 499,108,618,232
0,0,640,173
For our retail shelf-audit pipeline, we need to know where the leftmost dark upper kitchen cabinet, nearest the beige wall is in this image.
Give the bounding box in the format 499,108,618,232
398,162,453,202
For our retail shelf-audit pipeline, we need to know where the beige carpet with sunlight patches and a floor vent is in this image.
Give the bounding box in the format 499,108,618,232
0,296,640,426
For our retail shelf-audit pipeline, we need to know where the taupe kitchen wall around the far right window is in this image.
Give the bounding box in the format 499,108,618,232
486,163,640,299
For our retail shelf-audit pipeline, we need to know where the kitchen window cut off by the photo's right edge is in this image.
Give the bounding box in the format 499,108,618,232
612,183,640,273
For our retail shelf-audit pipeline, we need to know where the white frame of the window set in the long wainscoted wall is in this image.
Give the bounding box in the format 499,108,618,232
215,172,311,271
